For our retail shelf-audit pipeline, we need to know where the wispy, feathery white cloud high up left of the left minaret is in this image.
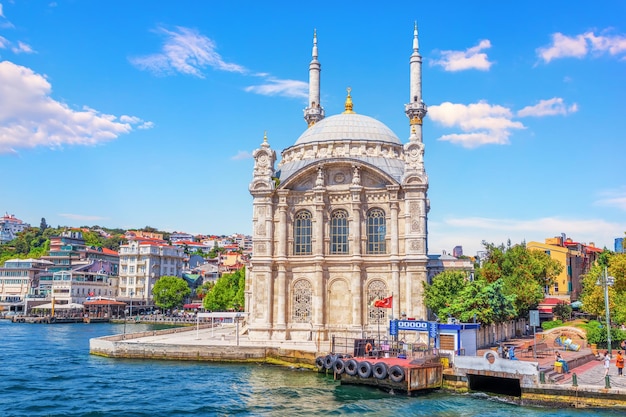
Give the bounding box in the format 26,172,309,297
130,27,247,78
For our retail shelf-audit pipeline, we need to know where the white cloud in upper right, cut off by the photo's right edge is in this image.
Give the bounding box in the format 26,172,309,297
537,32,626,62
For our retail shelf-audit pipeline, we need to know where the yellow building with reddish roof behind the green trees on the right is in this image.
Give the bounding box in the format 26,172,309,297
526,235,602,301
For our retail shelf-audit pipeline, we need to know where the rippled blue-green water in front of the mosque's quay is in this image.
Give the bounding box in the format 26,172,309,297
0,320,623,417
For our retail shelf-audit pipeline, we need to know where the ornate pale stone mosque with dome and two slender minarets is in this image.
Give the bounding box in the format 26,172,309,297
245,25,429,340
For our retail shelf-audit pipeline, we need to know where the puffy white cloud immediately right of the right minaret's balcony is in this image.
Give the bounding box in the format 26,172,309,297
428,101,524,148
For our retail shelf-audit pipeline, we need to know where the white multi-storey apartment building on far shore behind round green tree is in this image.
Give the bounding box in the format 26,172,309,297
117,239,185,305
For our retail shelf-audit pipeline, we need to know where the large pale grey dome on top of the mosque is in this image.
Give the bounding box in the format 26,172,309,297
295,113,402,146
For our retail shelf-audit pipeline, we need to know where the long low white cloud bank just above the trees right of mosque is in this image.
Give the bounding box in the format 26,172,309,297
428,217,626,256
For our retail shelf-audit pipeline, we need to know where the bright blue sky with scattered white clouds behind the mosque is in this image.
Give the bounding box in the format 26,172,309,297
0,0,626,255
